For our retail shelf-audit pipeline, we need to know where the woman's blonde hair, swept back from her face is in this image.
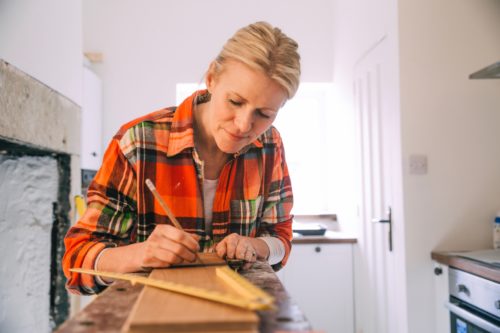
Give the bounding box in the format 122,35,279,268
209,22,300,99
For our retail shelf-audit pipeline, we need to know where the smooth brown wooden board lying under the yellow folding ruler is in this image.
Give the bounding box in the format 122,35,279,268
124,258,259,333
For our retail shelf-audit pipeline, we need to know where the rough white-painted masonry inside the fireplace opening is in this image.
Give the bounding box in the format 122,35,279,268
0,156,59,333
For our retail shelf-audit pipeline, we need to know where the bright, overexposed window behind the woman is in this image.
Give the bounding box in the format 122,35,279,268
177,83,354,215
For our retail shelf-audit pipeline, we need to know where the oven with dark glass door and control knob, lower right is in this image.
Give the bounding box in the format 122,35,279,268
447,267,500,333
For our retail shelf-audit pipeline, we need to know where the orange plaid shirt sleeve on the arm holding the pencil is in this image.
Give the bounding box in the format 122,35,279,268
62,138,136,294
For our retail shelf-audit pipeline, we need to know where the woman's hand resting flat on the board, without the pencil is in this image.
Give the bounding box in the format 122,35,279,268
215,233,269,269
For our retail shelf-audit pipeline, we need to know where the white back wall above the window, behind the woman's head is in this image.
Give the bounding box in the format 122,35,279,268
83,0,333,146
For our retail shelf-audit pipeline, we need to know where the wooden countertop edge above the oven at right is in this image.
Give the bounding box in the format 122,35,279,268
431,252,500,283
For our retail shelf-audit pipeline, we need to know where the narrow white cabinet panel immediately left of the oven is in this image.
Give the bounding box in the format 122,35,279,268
433,261,450,332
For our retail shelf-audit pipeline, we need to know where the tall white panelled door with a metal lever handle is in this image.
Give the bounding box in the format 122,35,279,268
354,38,407,333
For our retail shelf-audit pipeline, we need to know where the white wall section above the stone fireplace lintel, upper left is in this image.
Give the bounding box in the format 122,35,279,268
0,0,82,105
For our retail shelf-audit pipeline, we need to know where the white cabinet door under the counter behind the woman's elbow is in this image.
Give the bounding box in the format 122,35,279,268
279,244,354,333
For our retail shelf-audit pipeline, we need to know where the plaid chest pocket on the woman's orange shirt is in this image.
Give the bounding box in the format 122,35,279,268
229,196,262,236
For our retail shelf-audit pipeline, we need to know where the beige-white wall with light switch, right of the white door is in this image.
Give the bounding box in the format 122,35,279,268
400,0,500,332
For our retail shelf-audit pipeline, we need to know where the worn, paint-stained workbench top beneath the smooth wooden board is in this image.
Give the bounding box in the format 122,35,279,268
56,262,312,333
